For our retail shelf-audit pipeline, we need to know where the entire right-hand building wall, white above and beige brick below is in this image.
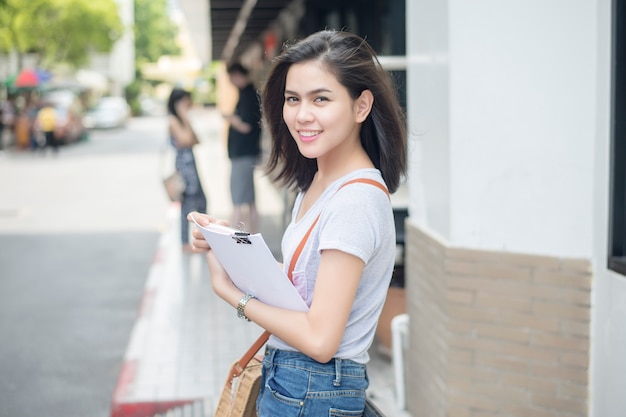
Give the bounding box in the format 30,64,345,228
406,0,626,417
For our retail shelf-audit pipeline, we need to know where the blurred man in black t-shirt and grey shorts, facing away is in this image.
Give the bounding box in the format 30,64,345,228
224,62,261,233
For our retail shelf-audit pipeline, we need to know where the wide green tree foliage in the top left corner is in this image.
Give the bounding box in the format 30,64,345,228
0,0,124,67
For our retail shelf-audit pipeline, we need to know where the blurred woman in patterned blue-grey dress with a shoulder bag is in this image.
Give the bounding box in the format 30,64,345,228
167,88,206,252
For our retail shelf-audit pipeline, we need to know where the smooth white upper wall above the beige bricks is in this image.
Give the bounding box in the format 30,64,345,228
407,0,597,258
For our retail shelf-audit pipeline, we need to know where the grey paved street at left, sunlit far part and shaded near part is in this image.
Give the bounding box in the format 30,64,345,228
0,118,168,417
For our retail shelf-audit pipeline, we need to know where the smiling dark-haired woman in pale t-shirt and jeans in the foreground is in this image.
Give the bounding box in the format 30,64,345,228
188,31,406,417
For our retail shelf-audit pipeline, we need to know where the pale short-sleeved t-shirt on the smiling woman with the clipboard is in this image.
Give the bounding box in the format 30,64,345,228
268,169,396,363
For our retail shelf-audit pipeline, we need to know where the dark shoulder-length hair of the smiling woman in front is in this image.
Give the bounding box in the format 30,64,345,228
262,30,406,193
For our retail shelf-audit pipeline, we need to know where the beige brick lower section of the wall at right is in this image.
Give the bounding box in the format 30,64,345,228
406,222,591,417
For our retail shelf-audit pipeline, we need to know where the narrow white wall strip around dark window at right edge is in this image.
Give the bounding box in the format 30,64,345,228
590,0,626,417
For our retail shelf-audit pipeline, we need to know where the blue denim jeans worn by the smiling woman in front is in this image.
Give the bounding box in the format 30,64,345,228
256,348,369,417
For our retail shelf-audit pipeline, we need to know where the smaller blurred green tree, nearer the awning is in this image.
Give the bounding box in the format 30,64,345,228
135,0,180,68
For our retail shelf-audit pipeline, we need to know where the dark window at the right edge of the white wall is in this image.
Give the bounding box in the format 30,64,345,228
608,0,626,275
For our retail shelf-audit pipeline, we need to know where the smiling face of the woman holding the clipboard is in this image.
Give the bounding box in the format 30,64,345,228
283,61,363,159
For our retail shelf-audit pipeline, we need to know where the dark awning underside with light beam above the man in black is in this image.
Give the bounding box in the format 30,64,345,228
208,0,293,61
